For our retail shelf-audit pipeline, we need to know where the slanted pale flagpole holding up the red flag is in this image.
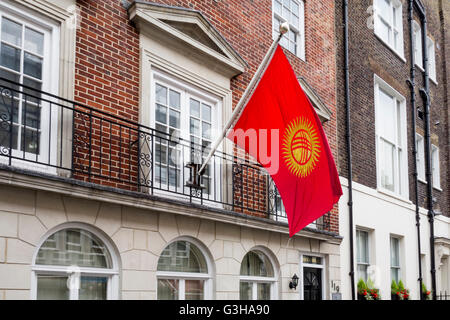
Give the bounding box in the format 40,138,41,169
198,22,289,175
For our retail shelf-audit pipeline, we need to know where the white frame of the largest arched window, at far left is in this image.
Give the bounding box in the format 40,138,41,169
30,222,120,300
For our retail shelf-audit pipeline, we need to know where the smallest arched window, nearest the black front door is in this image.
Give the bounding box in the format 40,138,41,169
239,250,277,300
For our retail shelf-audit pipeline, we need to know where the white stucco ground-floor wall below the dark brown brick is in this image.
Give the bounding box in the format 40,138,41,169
339,177,450,299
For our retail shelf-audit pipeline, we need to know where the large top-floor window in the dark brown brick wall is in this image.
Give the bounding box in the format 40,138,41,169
374,0,403,58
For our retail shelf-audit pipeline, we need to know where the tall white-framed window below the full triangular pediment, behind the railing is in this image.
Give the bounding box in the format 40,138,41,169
152,71,220,200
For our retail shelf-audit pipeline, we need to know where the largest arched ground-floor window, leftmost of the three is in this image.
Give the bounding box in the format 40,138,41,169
32,226,119,300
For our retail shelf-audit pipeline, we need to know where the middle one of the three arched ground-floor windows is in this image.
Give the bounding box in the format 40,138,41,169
157,240,212,300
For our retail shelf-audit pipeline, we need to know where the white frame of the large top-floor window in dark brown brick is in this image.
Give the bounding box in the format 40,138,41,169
373,0,406,62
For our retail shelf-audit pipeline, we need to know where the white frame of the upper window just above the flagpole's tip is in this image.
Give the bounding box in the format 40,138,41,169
272,0,306,61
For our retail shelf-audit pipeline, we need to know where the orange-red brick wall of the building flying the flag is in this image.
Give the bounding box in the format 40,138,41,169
75,0,338,232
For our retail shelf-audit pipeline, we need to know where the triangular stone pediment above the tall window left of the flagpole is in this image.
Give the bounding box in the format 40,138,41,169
128,1,247,78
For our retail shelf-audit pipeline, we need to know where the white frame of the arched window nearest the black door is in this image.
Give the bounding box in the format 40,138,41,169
239,247,279,300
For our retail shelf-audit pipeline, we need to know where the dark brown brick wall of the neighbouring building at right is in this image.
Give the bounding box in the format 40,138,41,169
336,0,449,214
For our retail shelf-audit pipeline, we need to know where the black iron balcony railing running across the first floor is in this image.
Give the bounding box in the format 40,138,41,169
0,78,332,231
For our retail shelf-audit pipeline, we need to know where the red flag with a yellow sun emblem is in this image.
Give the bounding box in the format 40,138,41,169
228,45,342,237
